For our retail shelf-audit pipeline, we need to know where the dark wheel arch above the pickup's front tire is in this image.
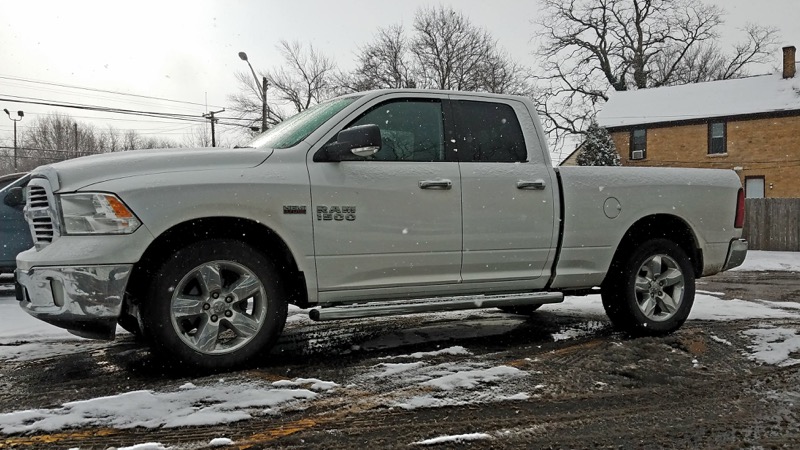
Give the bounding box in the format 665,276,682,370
126,217,308,307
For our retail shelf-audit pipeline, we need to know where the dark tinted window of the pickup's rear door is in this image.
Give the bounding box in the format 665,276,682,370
452,100,528,162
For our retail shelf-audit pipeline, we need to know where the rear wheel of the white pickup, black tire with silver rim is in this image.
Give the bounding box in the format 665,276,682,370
601,239,695,335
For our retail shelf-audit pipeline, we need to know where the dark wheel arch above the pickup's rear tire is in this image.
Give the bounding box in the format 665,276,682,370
609,214,703,278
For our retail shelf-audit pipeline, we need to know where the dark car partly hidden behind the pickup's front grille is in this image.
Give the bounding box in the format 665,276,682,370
0,174,33,274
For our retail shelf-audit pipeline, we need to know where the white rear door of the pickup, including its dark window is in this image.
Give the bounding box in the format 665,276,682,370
451,95,558,288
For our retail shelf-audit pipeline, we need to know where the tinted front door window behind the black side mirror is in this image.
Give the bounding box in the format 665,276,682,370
348,100,445,161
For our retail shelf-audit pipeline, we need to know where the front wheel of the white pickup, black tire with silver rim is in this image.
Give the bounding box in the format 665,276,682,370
141,239,287,370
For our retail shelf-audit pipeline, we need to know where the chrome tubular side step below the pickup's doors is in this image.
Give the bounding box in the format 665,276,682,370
308,292,564,321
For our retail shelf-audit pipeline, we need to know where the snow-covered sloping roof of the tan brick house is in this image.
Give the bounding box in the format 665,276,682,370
597,74,800,128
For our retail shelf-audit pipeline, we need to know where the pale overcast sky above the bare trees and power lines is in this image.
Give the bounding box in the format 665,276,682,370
0,0,800,145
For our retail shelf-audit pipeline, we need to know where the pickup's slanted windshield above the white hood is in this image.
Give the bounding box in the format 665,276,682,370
246,96,359,148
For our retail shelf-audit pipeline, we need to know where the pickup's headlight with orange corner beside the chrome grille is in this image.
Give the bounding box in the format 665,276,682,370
59,193,142,234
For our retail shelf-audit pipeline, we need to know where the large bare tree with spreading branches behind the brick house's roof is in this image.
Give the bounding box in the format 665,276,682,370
536,0,777,148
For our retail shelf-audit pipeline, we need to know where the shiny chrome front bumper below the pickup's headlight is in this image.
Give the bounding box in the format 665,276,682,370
16,264,133,340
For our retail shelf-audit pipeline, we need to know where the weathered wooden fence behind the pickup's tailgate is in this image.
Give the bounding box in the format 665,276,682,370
743,198,800,252
